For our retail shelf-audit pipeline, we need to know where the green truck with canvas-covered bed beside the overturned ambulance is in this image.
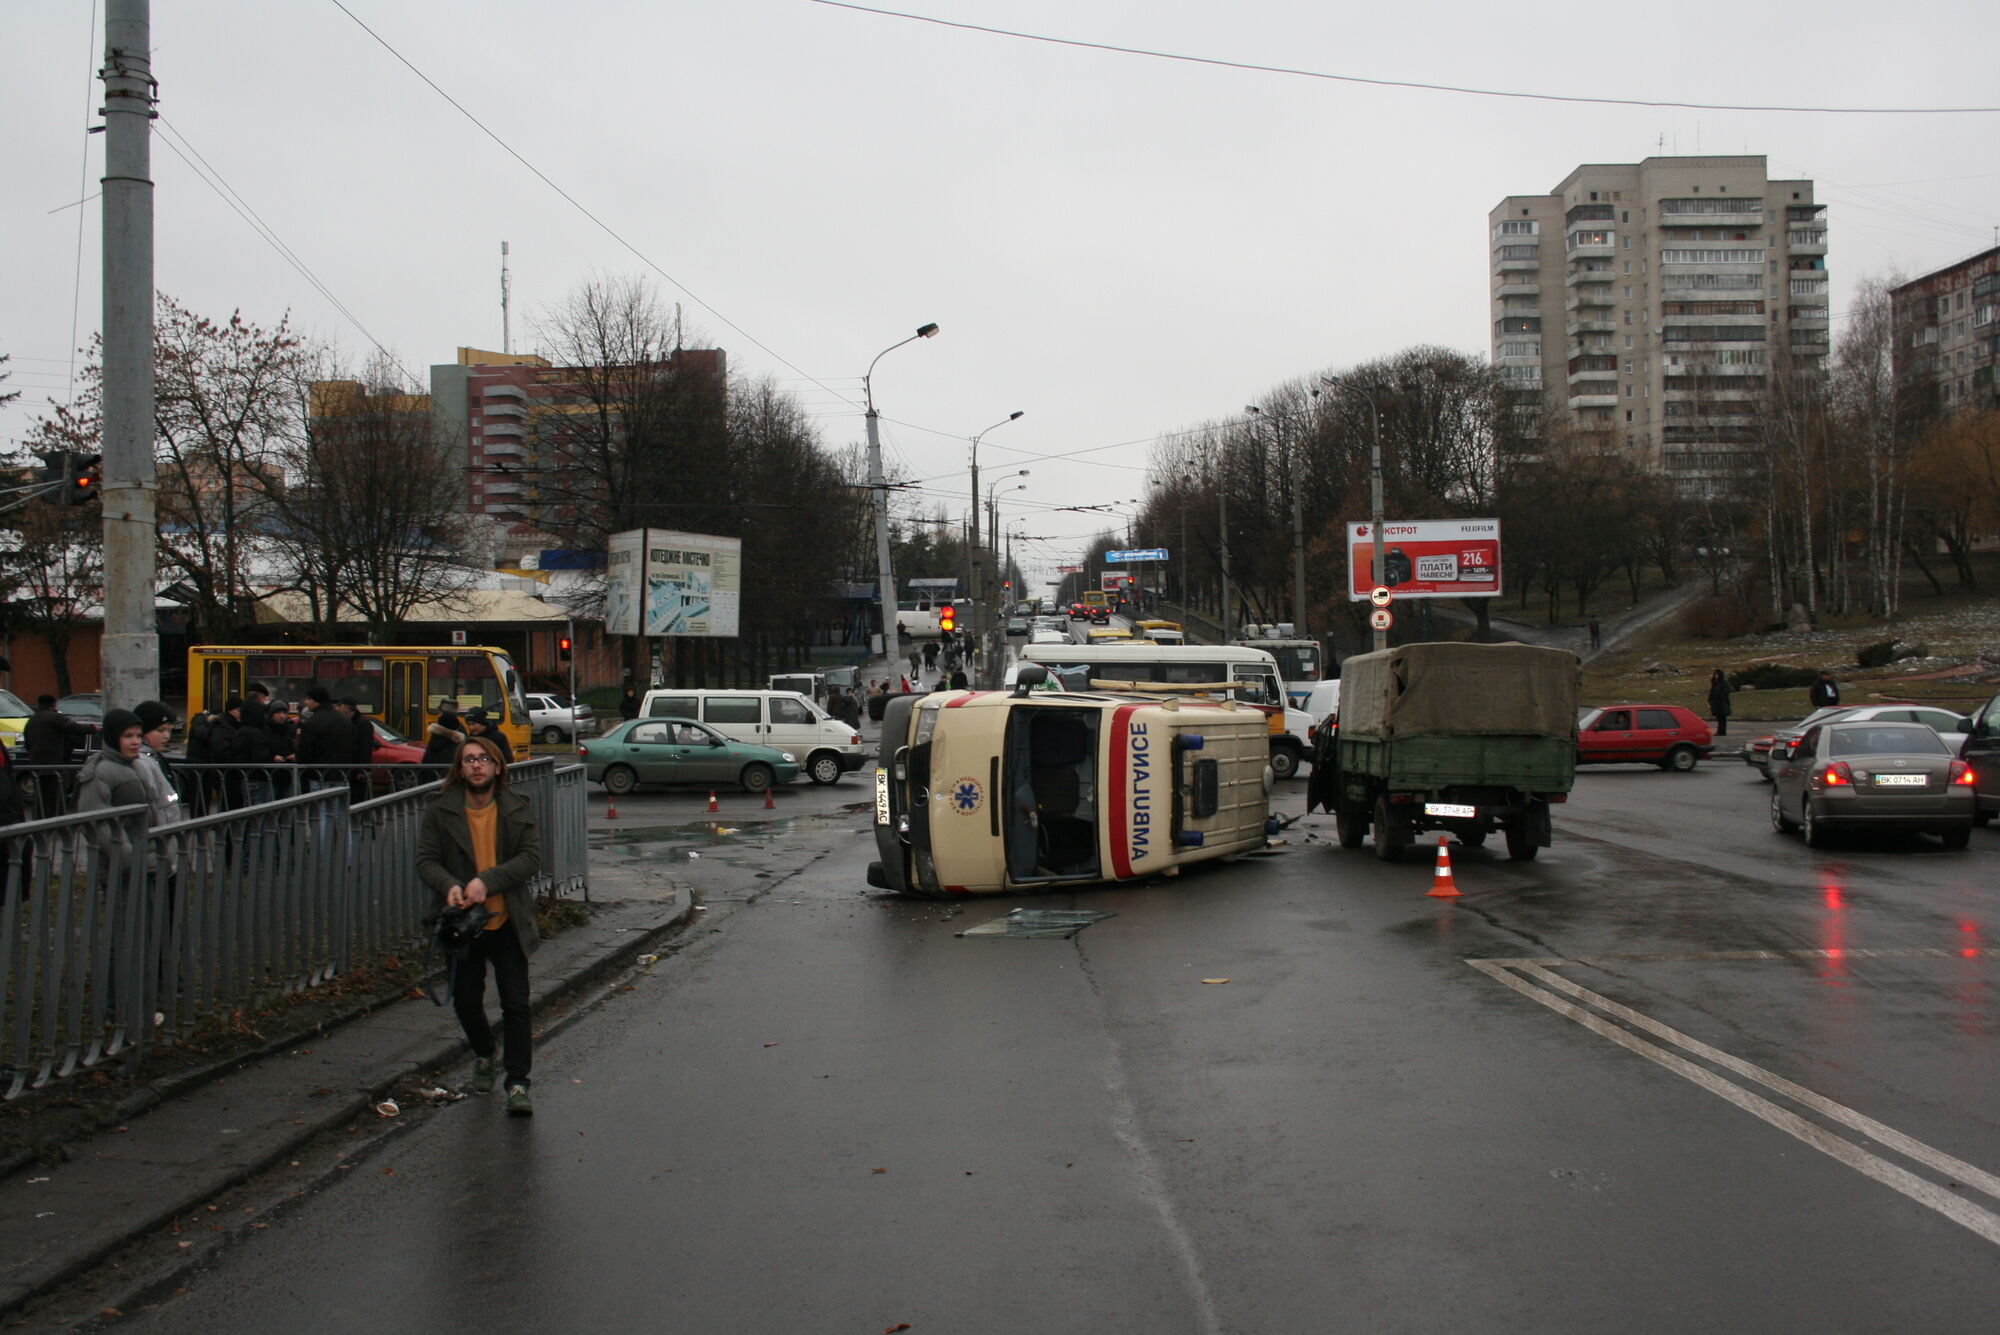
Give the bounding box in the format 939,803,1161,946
1306,644,1582,861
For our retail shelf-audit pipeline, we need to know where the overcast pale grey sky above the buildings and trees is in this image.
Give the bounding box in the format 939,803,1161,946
0,0,2000,587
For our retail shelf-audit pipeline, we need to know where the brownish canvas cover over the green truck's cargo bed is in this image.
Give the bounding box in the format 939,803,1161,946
1340,644,1582,739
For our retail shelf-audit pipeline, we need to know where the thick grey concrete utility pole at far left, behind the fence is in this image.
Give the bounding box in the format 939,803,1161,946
98,0,160,709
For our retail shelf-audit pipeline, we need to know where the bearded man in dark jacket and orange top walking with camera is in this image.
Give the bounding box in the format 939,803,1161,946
416,737,542,1117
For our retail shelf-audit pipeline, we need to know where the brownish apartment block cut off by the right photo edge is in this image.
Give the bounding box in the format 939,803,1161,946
1890,246,2000,414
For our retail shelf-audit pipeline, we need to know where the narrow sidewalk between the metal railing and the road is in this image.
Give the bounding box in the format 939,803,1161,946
0,867,692,1315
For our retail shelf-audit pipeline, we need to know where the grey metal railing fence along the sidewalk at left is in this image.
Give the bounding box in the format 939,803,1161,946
0,757,588,1099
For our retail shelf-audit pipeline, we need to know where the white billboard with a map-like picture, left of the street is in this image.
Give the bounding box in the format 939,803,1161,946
604,528,742,640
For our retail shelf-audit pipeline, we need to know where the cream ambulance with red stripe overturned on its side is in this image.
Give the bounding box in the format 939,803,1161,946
868,666,1272,897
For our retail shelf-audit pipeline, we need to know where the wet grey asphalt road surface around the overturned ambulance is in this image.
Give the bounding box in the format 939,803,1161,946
126,761,2000,1335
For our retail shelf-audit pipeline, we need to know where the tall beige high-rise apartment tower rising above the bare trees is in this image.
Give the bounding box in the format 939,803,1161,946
1488,156,1828,494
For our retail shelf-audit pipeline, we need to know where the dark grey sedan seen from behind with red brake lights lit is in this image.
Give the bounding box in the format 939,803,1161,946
1770,719,1974,847
